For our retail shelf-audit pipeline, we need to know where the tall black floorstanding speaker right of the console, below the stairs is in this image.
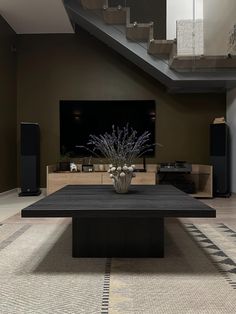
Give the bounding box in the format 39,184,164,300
210,123,231,197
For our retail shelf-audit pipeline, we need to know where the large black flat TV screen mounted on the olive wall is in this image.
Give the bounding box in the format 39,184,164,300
60,100,156,157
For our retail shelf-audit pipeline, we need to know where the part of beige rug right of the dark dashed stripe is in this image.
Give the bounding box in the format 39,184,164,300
109,223,236,314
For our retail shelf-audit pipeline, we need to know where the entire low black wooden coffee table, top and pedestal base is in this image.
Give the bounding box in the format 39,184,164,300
21,185,216,257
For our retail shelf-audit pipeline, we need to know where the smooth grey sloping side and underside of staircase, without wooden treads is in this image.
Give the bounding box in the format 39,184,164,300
64,0,236,93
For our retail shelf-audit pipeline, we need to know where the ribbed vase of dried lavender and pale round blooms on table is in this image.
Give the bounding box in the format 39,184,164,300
88,124,155,193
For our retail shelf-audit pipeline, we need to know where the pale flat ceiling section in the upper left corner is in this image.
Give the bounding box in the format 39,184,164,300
0,0,74,34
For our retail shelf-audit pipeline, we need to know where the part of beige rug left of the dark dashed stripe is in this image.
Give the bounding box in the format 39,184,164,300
0,224,106,314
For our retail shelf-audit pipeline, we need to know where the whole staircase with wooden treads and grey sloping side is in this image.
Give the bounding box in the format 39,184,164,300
64,0,236,92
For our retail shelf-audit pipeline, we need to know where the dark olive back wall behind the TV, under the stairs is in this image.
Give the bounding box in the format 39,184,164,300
18,31,225,186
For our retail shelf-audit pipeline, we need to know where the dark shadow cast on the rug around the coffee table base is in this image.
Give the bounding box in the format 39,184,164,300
34,222,218,276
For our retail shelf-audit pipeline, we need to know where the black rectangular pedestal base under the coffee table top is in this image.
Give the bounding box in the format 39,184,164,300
72,217,164,257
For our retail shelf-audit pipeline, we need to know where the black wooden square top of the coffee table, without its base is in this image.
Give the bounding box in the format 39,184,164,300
21,185,216,217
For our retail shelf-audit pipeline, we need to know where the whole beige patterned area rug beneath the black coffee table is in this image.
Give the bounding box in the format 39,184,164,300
0,220,236,314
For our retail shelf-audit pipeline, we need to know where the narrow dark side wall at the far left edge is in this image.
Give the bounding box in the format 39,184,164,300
0,16,17,193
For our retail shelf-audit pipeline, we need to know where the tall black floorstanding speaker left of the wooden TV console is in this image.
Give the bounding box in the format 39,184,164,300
19,122,41,196
